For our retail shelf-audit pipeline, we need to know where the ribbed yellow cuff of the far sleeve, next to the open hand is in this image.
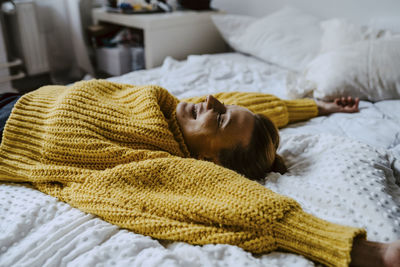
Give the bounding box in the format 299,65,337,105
284,98,318,123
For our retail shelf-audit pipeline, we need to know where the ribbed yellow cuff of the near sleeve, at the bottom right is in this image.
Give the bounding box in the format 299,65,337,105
274,210,366,266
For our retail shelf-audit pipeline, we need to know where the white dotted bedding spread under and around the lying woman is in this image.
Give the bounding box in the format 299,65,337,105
0,53,400,267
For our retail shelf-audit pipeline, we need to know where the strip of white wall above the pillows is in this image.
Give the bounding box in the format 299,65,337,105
211,0,400,23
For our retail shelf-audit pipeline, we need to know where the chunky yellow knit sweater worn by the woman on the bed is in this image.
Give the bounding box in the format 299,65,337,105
0,80,365,266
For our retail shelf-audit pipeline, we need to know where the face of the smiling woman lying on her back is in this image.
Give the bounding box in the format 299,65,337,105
176,95,255,164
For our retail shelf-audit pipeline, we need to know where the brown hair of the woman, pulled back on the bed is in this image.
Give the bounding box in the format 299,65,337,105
219,114,287,180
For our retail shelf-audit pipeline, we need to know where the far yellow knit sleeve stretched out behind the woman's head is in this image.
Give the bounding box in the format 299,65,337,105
182,92,318,128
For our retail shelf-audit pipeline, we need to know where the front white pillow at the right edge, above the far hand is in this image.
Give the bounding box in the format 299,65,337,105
287,36,400,101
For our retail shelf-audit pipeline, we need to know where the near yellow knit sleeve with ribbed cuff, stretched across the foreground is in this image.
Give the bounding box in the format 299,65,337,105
34,154,365,266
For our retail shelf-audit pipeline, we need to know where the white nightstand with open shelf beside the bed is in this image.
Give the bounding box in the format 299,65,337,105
92,8,226,69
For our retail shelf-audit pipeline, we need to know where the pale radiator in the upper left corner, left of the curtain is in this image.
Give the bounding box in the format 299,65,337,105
13,0,49,75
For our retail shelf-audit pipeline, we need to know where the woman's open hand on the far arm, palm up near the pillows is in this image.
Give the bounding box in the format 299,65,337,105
315,96,360,116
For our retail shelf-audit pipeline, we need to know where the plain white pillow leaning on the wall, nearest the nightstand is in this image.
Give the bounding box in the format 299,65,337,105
214,7,322,72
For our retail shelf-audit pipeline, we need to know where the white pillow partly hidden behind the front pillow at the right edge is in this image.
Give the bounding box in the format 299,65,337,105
320,18,391,53
